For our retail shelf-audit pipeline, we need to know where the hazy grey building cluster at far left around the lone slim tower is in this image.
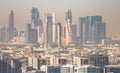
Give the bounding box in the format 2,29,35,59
0,10,17,42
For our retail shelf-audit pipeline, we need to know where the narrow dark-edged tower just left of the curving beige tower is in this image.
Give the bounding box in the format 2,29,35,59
57,23,62,48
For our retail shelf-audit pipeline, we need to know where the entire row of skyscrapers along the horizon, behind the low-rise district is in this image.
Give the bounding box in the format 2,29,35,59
0,7,106,48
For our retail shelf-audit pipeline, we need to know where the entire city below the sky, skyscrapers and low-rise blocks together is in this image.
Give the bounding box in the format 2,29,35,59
0,7,120,73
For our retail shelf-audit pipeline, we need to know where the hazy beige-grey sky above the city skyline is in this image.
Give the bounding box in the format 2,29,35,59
0,0,120,35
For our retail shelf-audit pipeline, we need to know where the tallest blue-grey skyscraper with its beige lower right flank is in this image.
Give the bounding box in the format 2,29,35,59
31,7,44,43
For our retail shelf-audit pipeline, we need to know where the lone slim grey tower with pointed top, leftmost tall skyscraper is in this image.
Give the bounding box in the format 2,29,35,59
8,11,15,40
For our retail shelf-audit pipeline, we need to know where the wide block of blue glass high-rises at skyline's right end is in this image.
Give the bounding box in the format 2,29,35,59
79,16,106,43
